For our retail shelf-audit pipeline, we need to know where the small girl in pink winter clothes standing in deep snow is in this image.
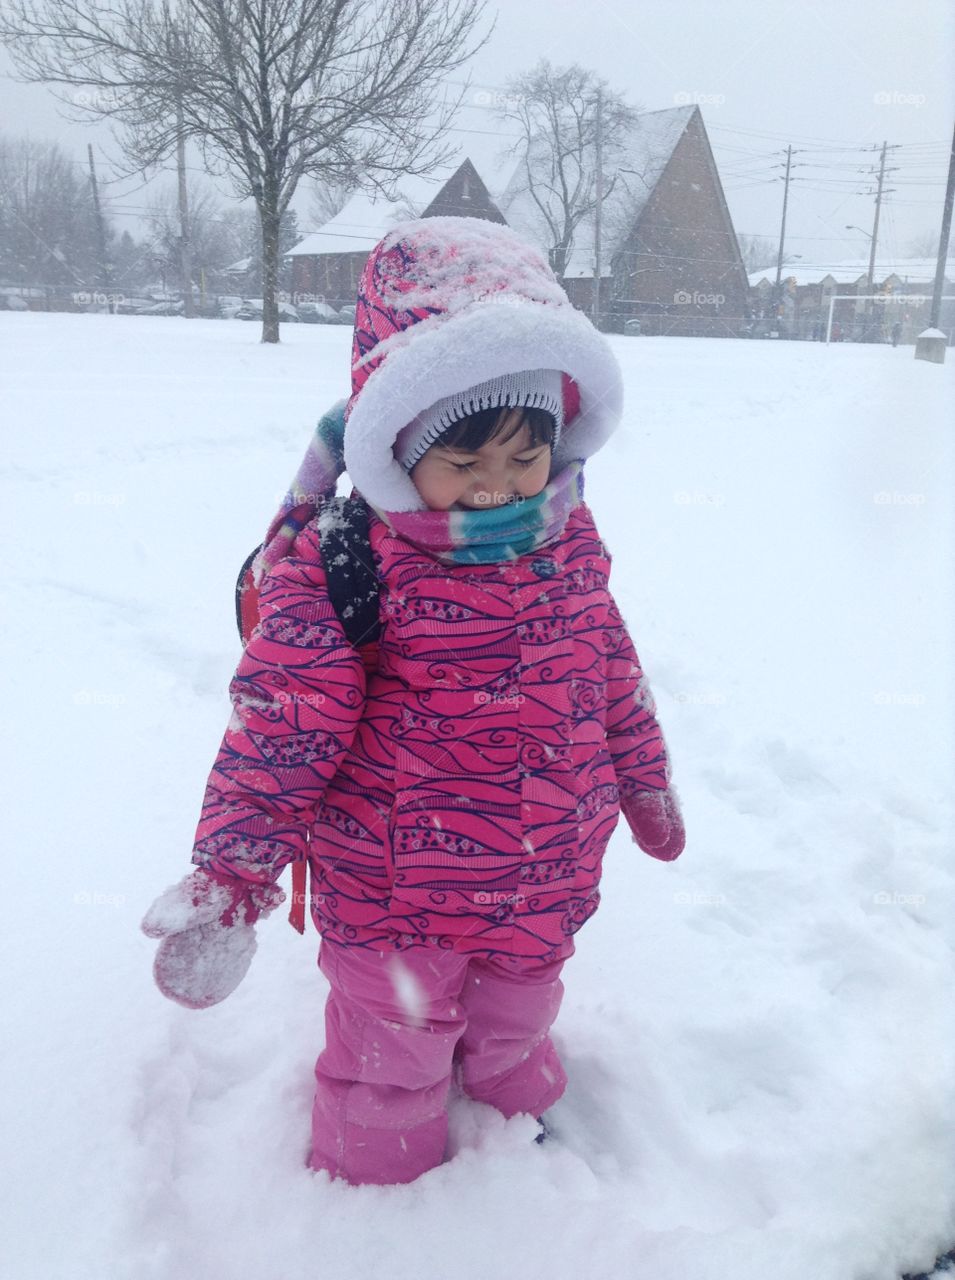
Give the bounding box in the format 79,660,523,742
143,218,684,1183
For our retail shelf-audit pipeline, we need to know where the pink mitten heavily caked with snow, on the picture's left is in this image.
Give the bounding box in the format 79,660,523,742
141,868,285,1009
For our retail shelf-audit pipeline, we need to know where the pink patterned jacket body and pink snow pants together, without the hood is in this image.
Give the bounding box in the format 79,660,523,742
193,219,672,1183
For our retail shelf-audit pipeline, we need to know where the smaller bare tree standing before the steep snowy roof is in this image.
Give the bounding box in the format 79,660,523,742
497,59,638,278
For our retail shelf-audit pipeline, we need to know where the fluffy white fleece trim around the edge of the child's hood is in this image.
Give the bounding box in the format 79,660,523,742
344,300,623,511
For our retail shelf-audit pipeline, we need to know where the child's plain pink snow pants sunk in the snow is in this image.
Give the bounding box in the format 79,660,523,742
307,938,572,1184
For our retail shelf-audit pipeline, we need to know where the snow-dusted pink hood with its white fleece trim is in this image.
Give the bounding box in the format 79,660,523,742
344,218,622,512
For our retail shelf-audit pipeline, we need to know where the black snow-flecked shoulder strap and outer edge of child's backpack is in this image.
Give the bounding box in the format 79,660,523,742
236,497,380,648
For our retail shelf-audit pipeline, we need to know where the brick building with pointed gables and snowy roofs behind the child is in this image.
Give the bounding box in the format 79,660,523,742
289,105,750,337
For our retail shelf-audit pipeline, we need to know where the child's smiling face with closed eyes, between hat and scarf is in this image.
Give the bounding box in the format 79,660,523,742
411,408,550,511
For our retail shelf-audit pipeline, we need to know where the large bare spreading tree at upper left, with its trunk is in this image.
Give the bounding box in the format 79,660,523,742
0,0,493,342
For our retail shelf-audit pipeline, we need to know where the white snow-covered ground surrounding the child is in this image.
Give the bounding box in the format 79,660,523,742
0,314,955,1280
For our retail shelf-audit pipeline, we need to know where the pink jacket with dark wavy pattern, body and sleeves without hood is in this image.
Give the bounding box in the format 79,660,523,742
192,502,670,957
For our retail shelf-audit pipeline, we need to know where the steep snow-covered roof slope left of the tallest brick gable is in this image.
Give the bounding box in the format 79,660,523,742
498,104,696,278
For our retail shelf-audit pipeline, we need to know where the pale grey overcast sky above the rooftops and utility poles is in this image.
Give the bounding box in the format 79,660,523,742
0,0,955,264
